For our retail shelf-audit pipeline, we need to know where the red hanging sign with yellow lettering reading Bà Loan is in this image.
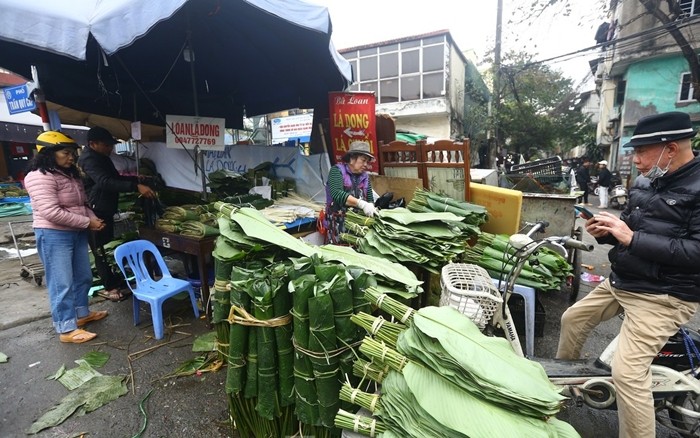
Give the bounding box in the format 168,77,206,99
328,91,379,172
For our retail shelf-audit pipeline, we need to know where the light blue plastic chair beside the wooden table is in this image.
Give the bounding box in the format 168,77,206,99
114,240,199,339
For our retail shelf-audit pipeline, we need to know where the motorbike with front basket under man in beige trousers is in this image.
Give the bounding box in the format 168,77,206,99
485,222,700,437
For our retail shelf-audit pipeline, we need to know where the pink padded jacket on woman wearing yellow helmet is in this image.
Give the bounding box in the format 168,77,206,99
24,170,95,231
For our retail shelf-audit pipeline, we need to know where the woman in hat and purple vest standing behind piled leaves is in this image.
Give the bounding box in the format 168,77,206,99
326,141,376,243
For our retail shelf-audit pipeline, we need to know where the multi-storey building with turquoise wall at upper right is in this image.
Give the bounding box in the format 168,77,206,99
596,0,700,180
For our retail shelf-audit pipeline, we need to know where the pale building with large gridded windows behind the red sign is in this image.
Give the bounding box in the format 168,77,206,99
339,30,489,157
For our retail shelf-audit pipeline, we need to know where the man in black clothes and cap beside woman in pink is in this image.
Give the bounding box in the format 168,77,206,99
78,126,156,301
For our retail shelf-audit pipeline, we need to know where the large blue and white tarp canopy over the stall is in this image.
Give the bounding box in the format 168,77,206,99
0,0,352,132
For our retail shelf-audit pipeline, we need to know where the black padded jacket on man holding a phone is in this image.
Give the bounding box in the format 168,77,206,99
598,156,700,302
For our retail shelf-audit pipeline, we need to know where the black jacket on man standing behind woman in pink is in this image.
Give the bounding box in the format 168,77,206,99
78,147,138,220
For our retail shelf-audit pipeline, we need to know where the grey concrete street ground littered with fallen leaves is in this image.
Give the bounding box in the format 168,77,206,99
0,197,700,438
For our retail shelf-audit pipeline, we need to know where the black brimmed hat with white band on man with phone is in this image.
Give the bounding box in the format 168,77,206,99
623,111,697,148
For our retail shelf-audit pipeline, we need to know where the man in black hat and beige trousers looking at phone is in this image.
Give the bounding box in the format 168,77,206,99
557,112,700,438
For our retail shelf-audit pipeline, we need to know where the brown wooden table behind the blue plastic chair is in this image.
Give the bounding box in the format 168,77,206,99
139,227,216,321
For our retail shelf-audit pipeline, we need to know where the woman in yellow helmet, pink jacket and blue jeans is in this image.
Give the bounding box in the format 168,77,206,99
24,131,107,344
